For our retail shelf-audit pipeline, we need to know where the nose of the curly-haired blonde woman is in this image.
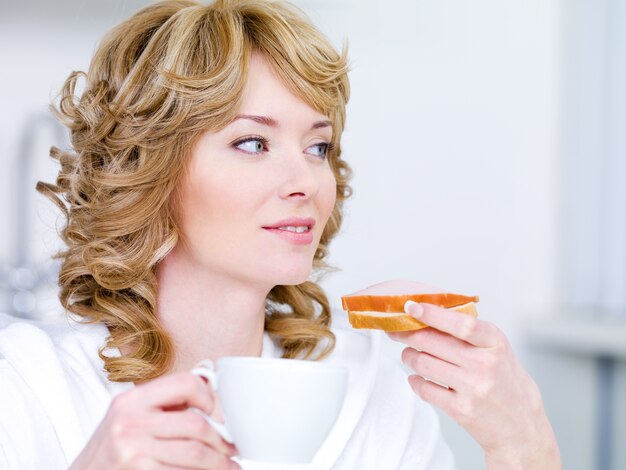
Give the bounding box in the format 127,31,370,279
278,153,322,200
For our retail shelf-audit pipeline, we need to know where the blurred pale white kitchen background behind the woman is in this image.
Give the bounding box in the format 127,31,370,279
0,0,626,470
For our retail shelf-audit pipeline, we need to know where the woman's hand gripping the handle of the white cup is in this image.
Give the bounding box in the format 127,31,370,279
70,372,239,470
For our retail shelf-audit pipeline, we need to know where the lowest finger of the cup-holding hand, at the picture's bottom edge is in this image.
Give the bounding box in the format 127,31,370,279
148,439,232,470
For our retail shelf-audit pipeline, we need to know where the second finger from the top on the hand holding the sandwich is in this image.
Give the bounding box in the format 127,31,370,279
388,328,475,366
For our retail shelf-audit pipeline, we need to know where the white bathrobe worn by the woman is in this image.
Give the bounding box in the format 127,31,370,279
0,312,454,470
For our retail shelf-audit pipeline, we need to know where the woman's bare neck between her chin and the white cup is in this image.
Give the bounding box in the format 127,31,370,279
157,252,269,372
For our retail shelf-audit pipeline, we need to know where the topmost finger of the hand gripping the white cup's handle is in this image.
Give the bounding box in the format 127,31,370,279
127,372,215,415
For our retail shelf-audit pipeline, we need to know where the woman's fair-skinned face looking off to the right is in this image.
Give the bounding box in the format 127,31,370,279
175,55,336,289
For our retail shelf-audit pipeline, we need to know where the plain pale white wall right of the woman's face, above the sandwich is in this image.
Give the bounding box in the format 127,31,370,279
306,1,559,338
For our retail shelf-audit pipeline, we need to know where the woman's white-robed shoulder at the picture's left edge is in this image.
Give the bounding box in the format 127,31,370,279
0,314,128,468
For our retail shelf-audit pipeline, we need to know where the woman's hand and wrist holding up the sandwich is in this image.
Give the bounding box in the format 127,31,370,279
388,301,561,470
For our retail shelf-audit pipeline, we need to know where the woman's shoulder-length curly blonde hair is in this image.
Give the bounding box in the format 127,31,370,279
37,0,350,382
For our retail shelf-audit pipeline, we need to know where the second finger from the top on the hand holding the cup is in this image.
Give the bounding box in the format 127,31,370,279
145,410,237,457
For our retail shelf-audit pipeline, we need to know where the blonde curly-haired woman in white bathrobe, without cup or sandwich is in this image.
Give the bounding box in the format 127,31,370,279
0,0,560,469
